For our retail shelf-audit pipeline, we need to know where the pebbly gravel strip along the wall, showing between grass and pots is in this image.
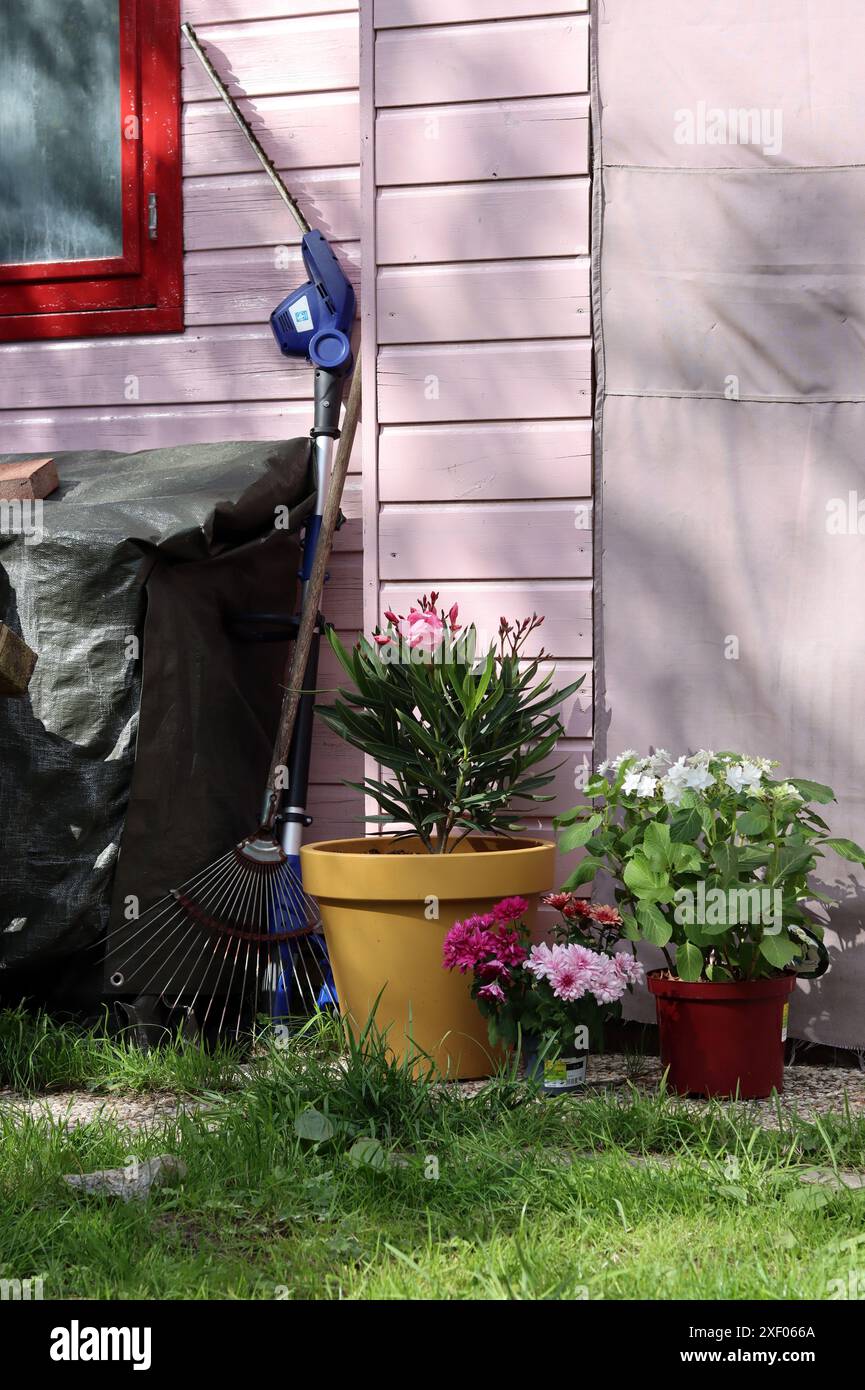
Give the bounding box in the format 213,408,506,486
0,1052,865,1131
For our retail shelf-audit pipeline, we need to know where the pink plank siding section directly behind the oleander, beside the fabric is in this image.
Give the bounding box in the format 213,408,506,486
360,0,592,839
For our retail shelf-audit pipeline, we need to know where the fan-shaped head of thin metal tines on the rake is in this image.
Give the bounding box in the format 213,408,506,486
107,834,332,1037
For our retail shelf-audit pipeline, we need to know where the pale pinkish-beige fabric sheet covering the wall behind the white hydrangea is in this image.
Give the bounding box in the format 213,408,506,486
592,0,865,1047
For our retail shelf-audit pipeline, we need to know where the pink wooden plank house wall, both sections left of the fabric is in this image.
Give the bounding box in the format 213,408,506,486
0,0,592,867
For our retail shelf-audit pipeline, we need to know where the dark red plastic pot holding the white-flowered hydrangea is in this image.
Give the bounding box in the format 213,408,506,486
648,970,795,1101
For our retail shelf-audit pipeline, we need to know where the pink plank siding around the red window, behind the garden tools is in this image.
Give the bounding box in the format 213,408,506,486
0,0,363,838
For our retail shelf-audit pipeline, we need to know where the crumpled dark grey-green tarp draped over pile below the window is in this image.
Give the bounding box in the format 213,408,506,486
0,439,313,980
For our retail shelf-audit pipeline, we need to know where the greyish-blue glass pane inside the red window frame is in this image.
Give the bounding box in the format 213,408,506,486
0,0,122,264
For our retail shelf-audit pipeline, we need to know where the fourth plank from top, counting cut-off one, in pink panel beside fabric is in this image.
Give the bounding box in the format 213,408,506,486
378,179,590,265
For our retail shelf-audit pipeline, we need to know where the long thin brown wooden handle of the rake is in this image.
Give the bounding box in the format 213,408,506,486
264,353,360,830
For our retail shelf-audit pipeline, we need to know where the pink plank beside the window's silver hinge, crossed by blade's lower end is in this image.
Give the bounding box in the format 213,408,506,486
184,170,360,252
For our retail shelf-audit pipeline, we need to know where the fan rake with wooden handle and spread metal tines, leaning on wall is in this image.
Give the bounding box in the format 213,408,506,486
106,360,360,1037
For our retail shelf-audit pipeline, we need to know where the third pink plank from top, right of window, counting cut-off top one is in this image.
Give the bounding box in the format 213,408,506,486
184,92,357,178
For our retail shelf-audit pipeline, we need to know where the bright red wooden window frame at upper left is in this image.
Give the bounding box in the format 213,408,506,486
0,0,184,342
